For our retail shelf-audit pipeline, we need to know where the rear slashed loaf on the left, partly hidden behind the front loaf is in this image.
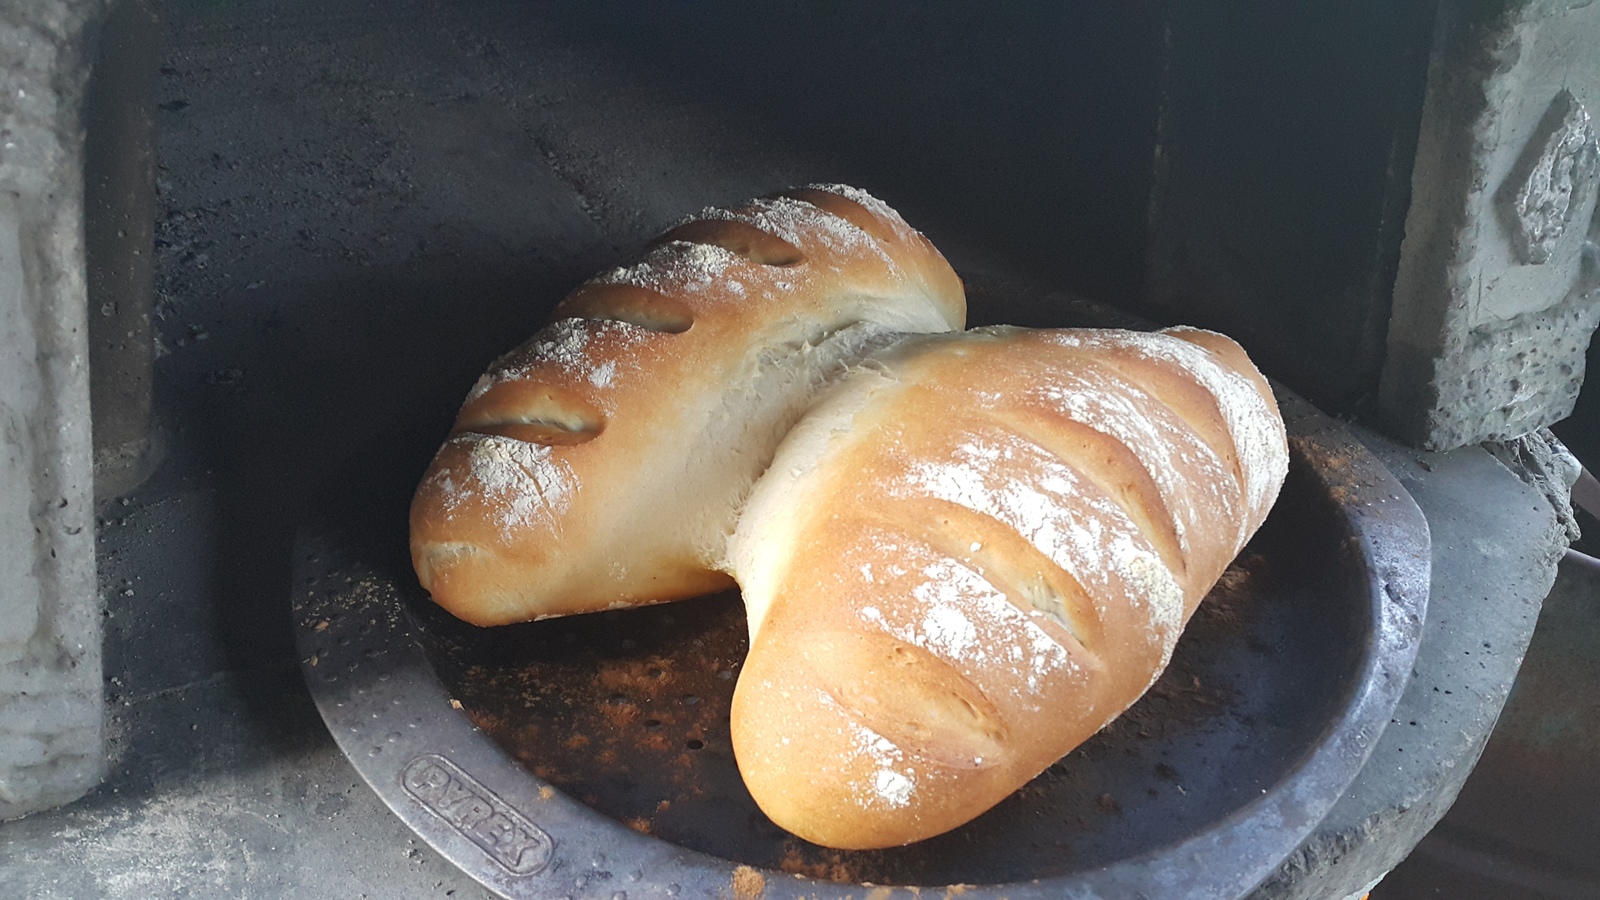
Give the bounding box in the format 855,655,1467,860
411,186,966,625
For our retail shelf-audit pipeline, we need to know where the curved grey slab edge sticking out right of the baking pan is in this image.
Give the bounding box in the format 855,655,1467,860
1256,434,1568,900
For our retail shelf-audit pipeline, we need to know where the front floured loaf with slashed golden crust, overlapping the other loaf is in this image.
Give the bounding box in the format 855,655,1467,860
728,328,1288,849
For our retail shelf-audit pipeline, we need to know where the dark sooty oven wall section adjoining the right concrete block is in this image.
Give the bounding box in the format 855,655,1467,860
1144,0,1435,413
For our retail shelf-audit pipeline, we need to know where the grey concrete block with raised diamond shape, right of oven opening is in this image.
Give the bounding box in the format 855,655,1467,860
1379,0,1600,450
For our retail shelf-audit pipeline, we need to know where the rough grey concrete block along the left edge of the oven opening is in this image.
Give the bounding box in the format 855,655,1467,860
0,0,104,820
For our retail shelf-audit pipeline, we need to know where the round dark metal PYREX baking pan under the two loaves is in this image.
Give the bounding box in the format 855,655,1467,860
294,387,1429,900
